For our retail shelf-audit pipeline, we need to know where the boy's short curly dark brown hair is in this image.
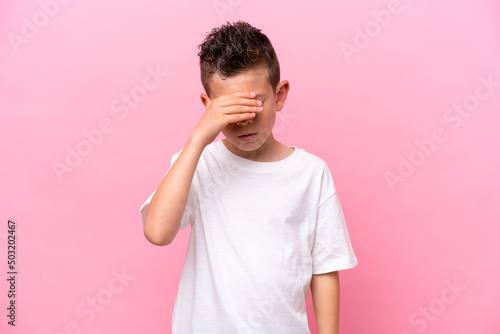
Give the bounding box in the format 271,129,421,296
198,20,280,96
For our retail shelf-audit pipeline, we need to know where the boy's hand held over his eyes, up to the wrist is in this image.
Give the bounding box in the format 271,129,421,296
192,92,262,145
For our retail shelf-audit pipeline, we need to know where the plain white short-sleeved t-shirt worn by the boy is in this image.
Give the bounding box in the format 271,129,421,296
140,140,358,334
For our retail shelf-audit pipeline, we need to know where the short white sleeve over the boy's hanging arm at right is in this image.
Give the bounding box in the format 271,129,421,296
311,167,358,275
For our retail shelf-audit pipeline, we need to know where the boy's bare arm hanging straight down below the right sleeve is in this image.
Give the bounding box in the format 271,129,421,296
311,271,340,334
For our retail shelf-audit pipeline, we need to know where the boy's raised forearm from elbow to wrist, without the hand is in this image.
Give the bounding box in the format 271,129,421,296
144,135,206,246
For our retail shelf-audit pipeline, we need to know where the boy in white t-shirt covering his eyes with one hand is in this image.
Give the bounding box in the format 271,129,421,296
140,21,358,334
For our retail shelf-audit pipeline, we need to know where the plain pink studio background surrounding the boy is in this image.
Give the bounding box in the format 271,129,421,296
0,0,500,334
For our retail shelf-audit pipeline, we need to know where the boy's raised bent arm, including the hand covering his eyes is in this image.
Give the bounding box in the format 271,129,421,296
144,92,262,246
